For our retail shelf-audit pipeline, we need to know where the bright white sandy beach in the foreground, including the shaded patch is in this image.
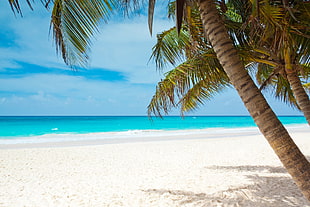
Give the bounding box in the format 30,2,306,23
0,126,310,207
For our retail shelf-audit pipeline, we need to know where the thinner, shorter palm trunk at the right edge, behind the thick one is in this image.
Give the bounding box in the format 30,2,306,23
286,71,310,125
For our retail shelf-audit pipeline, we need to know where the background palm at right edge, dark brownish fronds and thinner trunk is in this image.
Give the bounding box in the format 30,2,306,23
231,0,310,124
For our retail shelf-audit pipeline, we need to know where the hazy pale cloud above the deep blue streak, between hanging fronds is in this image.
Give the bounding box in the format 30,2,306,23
91,16,173,83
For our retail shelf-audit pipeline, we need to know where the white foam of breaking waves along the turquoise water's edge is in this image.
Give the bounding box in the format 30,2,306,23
0,125,309,145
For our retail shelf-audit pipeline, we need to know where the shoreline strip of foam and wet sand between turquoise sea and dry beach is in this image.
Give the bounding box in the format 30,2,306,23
0,124,310,150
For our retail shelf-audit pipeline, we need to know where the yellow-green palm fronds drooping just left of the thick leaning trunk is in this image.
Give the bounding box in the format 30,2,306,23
148,2,231,116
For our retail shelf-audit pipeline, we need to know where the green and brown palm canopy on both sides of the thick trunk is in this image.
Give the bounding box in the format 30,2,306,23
149,1,309,115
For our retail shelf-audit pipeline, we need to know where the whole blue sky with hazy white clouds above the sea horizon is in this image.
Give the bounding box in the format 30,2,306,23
0,1,301,116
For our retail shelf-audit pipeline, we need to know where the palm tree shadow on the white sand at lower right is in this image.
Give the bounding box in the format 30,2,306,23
143,163,310,207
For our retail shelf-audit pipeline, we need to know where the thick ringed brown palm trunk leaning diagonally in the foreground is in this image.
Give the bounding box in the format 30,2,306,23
198,0,310,201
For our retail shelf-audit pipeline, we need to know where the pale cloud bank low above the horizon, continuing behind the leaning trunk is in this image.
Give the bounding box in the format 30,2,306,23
0,74,300,115
